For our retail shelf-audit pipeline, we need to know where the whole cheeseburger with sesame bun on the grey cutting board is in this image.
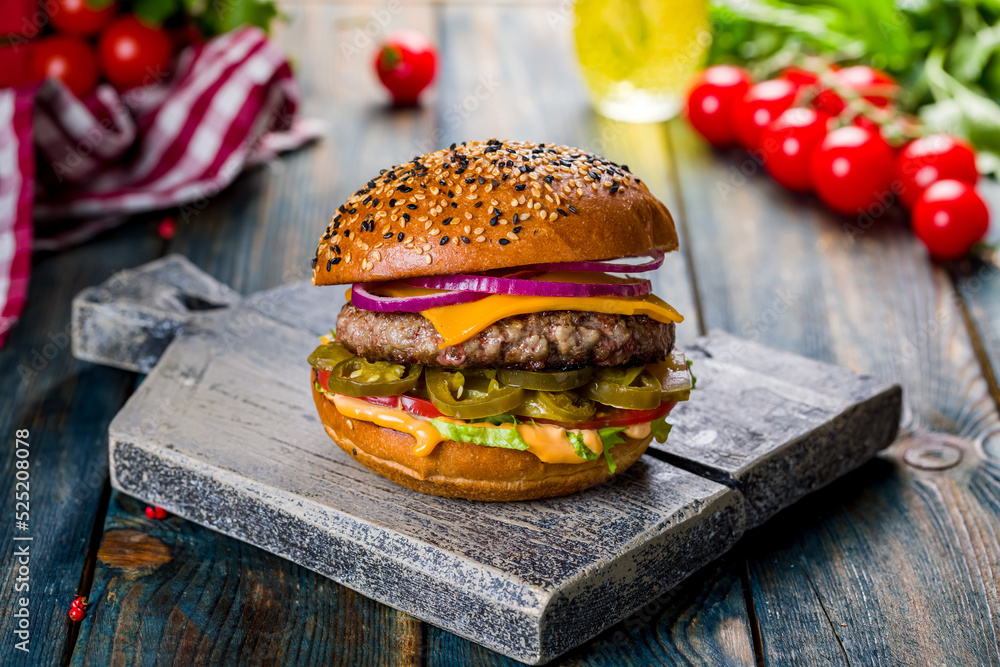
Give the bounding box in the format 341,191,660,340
309,139,692,501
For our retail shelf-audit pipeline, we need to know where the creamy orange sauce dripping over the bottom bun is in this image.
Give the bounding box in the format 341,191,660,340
327,394,604,463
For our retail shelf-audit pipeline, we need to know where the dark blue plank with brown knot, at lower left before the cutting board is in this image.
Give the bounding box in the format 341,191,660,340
73,492,422,665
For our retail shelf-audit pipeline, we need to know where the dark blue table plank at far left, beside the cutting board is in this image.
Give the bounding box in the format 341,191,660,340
0,223,161,664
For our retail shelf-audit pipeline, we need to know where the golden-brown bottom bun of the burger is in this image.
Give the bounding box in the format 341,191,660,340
313,386,653,501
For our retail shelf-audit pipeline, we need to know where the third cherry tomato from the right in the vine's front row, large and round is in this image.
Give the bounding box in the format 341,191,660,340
809,125,893,215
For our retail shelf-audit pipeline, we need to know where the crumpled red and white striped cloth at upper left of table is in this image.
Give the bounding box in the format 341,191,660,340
0,27,322,346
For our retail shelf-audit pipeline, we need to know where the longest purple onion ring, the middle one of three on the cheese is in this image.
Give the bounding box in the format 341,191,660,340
406,274,653,297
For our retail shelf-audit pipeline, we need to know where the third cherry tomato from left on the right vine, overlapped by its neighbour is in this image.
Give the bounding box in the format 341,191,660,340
760,107,830,192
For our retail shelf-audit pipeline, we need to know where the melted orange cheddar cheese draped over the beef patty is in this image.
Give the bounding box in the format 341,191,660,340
368,271,684,349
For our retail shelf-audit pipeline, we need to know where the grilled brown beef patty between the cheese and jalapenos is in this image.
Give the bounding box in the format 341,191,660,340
337,304,674,370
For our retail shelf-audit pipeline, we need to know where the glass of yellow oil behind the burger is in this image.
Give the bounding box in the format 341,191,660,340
574,0,712,123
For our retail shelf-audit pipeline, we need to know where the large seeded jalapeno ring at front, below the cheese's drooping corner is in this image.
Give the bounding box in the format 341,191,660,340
425,368,524,419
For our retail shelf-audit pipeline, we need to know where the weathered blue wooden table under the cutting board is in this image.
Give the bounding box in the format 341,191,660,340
0,1,1000,665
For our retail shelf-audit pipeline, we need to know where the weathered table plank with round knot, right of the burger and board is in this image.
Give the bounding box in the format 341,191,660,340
671,122,1000,664
